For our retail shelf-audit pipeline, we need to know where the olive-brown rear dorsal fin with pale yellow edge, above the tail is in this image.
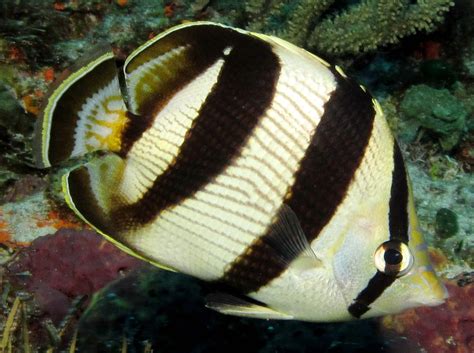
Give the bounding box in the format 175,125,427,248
123,22,250,115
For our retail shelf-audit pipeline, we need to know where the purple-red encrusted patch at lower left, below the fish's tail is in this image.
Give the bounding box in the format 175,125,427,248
7,229,141,323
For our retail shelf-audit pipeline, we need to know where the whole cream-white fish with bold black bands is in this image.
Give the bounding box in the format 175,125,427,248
36,22,446,321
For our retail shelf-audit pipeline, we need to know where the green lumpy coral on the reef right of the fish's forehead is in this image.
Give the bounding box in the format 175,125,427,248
400,84,468,151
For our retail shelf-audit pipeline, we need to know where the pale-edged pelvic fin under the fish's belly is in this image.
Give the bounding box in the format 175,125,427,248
206,293,293,320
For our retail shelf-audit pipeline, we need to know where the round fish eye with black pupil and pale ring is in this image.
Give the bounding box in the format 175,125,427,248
374,240,413,277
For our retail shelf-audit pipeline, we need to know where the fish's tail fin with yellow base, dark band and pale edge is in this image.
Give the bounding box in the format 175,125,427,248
34,51,127,168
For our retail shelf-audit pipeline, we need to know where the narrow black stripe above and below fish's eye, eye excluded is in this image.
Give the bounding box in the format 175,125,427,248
348,141,408,318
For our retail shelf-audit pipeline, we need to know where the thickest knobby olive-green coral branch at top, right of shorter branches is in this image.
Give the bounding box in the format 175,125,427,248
308,0,452,54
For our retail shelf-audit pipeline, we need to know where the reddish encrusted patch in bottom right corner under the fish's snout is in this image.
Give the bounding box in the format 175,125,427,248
383,274,474,353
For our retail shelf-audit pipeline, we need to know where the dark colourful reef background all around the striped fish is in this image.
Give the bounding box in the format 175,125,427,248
0,0,474,353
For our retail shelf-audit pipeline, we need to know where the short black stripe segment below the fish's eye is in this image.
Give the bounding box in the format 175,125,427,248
347,271,396,319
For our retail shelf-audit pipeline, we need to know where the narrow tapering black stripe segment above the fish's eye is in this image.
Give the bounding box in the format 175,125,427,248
388,142,408,243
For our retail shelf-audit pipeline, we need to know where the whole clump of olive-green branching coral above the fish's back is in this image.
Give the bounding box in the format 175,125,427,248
245,0,453,55
